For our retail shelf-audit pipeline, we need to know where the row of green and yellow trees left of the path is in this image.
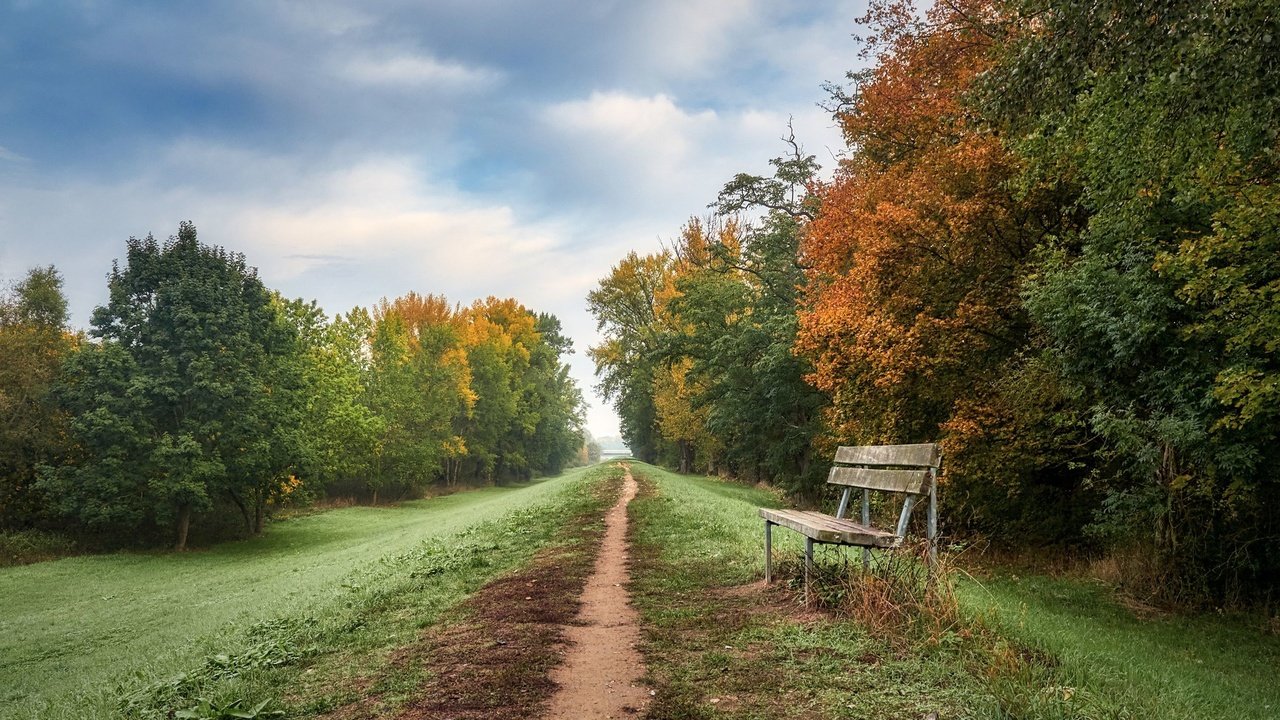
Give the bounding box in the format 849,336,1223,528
0,223,586,550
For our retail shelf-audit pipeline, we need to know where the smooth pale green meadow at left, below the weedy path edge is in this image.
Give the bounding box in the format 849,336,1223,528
0,470,599,719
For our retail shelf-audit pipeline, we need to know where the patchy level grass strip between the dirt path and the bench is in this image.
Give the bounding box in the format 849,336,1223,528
632,464,995,719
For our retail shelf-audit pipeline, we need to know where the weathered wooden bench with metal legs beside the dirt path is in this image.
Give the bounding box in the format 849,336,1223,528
760,443,942,591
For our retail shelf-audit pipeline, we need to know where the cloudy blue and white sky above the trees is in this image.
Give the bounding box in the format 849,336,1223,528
0,0,865,437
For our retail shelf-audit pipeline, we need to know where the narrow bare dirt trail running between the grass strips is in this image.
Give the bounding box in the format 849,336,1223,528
547,465,649,720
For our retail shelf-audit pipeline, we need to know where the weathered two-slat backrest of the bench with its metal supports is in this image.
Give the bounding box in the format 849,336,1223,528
827,442,942,540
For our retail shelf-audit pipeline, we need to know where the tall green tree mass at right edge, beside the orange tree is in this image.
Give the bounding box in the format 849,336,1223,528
979,0,1280,600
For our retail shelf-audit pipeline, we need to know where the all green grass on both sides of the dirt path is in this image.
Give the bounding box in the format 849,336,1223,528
0,462,1280,720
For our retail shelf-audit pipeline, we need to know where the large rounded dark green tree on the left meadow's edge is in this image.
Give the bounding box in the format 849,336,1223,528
41,223,297,550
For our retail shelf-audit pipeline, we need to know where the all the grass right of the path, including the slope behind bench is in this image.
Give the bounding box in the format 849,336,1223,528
632,464,1280,720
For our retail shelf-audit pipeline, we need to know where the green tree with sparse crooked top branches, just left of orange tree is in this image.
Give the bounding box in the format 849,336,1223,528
673,210,826,498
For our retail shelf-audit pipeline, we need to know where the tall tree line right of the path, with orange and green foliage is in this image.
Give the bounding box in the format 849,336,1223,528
590,0,1280,602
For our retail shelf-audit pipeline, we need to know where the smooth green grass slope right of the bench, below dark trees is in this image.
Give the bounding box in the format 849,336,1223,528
961,574,1280,720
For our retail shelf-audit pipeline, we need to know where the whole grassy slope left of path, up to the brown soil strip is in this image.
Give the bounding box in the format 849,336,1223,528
0,468,619,720
